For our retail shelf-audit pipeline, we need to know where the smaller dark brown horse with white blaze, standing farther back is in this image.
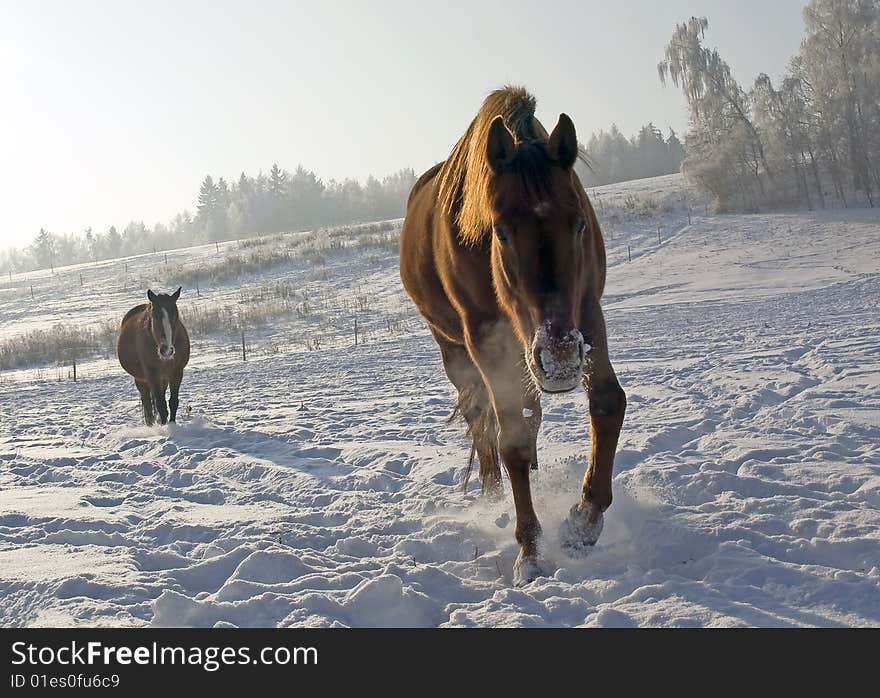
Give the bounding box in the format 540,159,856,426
116,288,189,426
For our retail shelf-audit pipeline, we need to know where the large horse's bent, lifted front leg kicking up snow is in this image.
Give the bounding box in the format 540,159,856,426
561,304,626,552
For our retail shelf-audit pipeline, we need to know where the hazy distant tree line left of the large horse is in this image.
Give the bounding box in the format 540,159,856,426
0,164,416,274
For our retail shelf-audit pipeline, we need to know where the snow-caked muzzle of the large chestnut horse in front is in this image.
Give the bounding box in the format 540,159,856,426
528,322,590,393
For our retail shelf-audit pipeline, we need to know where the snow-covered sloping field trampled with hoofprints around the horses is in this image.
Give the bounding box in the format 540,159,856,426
0,178,880,626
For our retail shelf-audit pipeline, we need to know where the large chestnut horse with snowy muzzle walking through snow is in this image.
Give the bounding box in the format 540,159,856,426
400,87,626,584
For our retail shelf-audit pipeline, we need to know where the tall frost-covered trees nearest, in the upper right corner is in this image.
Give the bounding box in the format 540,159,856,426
658,0,880,210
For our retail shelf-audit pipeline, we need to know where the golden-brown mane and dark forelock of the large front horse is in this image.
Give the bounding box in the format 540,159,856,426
437,85,548,244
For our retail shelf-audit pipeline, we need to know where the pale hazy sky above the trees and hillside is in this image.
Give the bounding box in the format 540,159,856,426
0,0,805,247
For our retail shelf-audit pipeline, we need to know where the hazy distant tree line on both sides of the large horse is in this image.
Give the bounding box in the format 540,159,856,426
0,118,684,274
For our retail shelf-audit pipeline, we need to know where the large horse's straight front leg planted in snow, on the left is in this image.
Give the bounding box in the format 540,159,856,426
466,321,541,585
